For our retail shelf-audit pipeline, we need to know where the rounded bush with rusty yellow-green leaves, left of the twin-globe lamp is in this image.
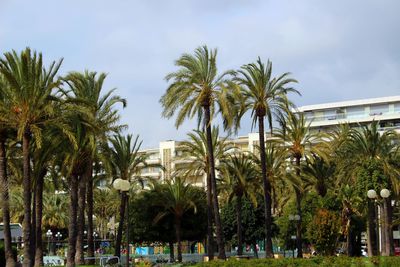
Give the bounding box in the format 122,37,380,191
308,209,340,255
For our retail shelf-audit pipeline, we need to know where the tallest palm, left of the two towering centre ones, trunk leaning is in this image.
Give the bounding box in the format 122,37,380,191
160,46,234,259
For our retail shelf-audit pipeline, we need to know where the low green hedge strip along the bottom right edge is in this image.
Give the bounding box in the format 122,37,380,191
196,257,400,267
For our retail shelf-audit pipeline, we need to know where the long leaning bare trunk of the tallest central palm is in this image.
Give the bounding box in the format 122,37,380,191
204,106,226,260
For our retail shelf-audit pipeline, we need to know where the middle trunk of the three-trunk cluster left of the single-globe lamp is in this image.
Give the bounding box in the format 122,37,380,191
75,174,87,265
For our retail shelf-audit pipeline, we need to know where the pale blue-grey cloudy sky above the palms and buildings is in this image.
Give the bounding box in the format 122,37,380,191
0,0,400,148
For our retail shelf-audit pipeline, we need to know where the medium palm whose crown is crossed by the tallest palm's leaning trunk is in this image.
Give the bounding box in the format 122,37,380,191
176,127,233,259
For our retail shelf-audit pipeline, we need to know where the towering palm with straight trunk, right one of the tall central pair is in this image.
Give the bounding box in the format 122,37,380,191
234,58,299,257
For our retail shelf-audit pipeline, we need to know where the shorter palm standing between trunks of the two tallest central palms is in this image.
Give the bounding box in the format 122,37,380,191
221,153,259,255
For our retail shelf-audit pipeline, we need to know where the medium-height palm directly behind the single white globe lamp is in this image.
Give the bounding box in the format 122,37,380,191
106,134,149,257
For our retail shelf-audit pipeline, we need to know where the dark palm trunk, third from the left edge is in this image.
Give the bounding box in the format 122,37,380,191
35,171,47,267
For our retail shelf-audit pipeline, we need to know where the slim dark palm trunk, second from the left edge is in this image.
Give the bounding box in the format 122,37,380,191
22,130,33,267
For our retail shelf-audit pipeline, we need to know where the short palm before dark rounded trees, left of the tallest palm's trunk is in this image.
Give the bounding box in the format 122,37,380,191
154,177,198,262
